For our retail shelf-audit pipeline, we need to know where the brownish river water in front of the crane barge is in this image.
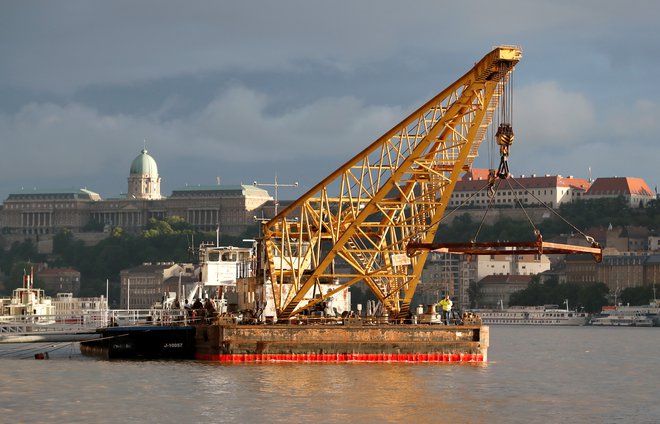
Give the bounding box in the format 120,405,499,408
0,326,660,424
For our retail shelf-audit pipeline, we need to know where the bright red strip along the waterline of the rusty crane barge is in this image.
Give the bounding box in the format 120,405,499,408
195,353,484,363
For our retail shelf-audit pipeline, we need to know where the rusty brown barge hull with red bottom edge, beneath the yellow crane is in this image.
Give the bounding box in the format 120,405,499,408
195,324,489,363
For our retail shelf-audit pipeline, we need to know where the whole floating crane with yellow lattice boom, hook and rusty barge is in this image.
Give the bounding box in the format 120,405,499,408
81,46,600,363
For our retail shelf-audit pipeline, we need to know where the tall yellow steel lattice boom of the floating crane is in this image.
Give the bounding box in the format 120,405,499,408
263,46,522,319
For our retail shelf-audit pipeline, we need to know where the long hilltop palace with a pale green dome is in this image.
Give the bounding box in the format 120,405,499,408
0,149,274,239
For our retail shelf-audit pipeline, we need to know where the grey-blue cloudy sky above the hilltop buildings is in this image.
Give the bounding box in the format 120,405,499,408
0,0,660,201
